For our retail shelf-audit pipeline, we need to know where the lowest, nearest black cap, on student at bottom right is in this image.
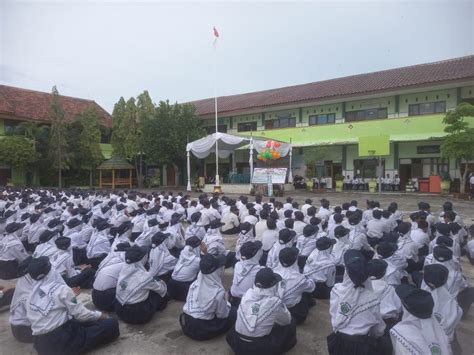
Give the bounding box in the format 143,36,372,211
395,284,434,319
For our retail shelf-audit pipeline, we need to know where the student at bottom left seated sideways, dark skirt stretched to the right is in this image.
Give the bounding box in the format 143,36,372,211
27,256,120,355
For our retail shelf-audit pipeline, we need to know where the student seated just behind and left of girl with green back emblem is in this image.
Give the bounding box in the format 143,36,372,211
303,237,336,300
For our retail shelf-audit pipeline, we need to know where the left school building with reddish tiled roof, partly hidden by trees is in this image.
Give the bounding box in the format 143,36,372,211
0,85,112,185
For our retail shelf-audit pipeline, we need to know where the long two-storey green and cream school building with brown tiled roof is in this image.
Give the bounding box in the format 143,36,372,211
192,56,474,192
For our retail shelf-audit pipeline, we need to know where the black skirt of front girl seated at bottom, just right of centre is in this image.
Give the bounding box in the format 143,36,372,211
226,319,296,355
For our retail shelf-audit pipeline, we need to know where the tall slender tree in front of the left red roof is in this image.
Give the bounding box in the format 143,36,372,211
48,86,68,188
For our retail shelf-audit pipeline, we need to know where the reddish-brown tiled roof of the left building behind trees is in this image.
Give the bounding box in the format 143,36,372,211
0,85,112,127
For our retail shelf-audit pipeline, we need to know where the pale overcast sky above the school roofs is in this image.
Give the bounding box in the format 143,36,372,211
0,0,474,112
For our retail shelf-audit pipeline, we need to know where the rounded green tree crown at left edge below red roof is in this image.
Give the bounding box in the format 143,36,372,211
0,136,38,168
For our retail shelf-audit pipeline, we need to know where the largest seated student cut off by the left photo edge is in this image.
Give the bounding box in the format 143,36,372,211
0,222,28,280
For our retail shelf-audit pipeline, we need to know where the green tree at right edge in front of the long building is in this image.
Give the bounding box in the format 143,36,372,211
441,102,474,193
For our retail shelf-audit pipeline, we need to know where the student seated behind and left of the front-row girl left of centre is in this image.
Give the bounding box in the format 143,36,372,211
167,236,201,302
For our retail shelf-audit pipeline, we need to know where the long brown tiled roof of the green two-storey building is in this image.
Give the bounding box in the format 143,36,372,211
190,55,474,116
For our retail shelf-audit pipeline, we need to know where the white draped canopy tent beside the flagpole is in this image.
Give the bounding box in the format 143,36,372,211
186,132,293,191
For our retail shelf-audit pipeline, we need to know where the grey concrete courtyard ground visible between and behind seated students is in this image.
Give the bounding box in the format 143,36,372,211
0,191,474,355
